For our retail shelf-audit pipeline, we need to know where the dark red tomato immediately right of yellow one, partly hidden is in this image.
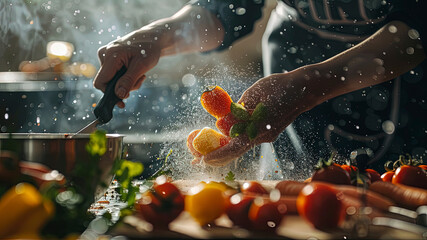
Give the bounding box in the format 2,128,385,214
226,193,255,229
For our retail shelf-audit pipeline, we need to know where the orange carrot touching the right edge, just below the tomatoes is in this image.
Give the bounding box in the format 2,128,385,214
369,181,427,209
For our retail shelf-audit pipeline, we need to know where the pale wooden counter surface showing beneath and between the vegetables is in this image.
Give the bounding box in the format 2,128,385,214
105,180,422,239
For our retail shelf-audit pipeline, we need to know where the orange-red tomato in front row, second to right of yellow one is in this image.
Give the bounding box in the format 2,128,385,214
248,198,286,231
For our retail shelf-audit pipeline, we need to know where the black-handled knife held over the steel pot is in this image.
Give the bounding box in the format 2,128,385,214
69,66,126,138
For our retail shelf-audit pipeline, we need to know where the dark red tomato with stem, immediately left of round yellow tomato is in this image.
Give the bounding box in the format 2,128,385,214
135,177,184,228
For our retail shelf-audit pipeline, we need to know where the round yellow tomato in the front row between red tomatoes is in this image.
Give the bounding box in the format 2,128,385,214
185,183,227,226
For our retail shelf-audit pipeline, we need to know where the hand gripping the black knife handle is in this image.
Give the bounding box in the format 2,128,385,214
93,29,162,108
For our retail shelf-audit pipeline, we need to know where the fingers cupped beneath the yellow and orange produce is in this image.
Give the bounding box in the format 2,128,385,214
202,136,253,166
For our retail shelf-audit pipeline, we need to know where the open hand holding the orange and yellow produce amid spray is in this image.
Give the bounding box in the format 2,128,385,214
202,69,315,166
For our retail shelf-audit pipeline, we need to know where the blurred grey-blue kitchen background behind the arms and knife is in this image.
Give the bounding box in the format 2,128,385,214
0,0,276,179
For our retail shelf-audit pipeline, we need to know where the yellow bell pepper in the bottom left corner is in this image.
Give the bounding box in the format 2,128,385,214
0,183,55,239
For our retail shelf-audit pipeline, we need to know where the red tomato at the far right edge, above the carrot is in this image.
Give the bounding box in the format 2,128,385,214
391,165,427,189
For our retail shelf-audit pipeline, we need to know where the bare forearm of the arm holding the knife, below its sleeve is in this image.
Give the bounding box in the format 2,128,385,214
131,5,224,56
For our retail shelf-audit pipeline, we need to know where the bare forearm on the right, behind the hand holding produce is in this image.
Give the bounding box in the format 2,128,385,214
302,21,425,105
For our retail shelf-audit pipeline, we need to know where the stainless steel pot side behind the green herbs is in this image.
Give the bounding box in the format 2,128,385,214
0,133,123,196
